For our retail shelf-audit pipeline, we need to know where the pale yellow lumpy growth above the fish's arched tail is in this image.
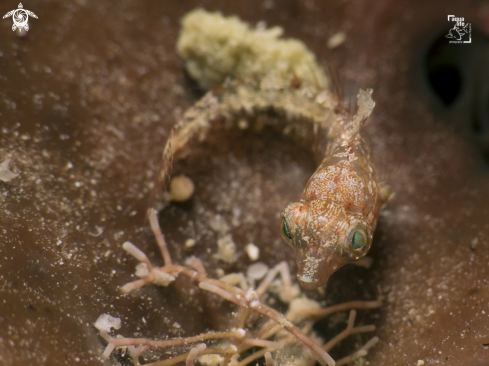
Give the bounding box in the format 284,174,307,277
177,9,328,89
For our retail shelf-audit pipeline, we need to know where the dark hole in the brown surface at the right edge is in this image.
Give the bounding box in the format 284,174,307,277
423,29,489,164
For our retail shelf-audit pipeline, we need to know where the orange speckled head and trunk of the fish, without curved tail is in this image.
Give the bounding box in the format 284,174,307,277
281,91,382,289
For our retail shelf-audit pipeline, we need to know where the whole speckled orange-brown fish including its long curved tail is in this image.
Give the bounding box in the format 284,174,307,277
160,80,380,288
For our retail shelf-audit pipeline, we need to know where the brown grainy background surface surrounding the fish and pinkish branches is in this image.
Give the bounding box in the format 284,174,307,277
0,0,489,365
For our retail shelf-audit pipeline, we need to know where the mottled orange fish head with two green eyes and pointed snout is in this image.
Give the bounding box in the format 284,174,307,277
281,200,373,289
